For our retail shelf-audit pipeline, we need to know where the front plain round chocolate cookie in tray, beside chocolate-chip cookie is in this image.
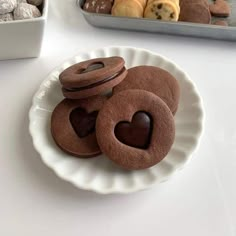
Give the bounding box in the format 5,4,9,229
179,3,211,24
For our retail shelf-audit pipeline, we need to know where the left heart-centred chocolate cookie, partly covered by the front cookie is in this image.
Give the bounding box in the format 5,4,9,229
51,96,107,158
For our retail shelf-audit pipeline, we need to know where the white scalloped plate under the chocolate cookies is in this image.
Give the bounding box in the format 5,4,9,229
29,47,203,194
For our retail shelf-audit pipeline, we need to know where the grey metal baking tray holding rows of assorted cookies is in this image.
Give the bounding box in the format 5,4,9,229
77,0,236,42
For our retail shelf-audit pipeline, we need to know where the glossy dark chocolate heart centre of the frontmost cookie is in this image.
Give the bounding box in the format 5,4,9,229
114,111,152,149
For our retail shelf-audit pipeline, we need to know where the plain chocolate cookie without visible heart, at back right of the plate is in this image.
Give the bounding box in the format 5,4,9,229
113,66,180,114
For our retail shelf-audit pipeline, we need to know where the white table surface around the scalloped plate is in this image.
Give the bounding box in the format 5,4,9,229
0,0,236,236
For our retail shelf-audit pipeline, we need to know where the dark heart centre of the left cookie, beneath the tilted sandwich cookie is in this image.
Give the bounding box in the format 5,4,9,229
70,107,98,138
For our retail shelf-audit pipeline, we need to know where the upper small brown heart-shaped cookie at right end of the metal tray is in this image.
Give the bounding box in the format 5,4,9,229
209,0,230,17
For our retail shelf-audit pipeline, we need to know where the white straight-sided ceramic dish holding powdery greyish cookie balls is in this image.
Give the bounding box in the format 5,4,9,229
0,0,48,60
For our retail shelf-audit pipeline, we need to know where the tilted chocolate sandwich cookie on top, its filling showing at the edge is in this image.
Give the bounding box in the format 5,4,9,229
59,57,127,99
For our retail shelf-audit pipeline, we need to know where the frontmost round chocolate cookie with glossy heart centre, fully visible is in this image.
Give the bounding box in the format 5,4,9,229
96,90,175,170
